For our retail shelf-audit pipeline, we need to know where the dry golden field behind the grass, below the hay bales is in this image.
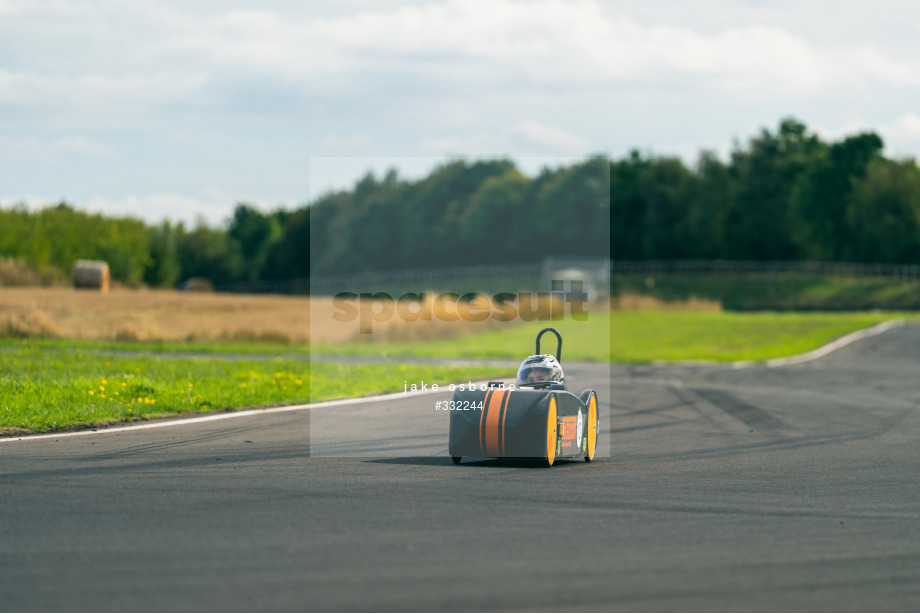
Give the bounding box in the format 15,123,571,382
0,287,561,343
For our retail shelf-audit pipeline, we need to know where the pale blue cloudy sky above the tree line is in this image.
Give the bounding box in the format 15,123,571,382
0,0,920,224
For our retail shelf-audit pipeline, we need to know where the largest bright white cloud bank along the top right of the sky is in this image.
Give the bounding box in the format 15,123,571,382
162,0,920,97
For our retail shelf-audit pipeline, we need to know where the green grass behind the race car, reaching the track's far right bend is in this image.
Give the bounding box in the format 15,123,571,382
314,311,905,363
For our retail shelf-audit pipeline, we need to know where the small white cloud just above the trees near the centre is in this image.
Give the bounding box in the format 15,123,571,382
421,120,589,156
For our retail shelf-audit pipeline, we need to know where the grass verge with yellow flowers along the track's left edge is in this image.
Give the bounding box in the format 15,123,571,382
0,342,508,433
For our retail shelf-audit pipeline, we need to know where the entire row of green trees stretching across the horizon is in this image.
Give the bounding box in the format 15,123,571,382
0,119,920,287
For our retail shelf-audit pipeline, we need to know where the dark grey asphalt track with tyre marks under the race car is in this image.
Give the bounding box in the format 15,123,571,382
0,326,920,611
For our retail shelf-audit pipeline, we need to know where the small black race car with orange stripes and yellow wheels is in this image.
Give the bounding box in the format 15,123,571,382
447,328,598,467
